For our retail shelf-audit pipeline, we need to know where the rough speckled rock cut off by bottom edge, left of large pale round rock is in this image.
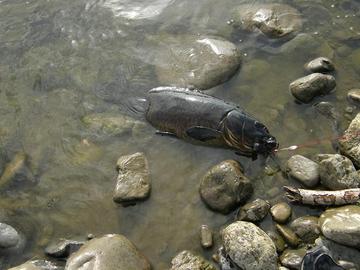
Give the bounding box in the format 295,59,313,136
170,250,216,270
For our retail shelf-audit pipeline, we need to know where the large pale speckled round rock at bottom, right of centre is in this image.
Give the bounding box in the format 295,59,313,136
221,221,277,270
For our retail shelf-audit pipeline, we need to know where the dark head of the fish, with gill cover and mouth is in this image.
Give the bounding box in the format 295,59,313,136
224,110,279,156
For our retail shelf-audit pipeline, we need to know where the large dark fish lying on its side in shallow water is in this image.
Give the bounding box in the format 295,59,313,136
145,87,278,158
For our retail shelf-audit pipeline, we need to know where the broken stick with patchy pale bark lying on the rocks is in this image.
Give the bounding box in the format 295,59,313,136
283,186,360,206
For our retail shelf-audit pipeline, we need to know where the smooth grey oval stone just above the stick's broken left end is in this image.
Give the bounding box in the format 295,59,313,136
286,155,320,188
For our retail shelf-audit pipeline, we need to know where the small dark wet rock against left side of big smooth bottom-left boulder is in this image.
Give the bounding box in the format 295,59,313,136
45,239,85,258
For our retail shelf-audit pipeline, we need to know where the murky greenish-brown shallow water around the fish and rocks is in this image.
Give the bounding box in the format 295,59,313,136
0,0,360,270
